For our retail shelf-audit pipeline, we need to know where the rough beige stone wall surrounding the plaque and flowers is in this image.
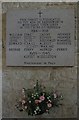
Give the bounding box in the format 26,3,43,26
2,3,77,118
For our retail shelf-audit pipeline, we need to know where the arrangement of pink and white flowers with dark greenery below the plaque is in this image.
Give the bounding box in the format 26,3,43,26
16,80,62,115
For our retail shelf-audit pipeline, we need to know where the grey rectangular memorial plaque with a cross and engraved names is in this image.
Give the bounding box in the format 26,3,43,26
6,8,75,66
